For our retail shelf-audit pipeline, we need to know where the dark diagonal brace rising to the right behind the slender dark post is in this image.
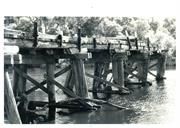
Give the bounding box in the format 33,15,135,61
25,65,71,95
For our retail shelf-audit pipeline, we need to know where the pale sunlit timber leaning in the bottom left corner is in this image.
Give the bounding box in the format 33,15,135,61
4,70,22,124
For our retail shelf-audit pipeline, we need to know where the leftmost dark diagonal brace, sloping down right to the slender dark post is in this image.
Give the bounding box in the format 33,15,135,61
13,67,51,94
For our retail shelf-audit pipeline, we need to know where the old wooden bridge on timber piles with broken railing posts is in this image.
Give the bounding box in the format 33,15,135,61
4,23,166,123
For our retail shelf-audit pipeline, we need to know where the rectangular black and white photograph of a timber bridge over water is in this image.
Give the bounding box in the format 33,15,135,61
1,0,177,126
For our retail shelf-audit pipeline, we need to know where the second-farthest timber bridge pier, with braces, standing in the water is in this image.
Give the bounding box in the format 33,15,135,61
125,50,150,88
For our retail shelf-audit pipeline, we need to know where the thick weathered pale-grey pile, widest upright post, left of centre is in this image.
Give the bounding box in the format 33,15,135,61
72,58,88,98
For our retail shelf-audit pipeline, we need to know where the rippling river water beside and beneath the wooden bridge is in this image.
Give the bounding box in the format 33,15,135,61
9,69,176,124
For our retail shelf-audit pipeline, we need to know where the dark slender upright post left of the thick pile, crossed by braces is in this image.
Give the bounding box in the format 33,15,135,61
46,64,56,121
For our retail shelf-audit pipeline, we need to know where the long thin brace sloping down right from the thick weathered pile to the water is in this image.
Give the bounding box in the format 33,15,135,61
86,72,129,91
